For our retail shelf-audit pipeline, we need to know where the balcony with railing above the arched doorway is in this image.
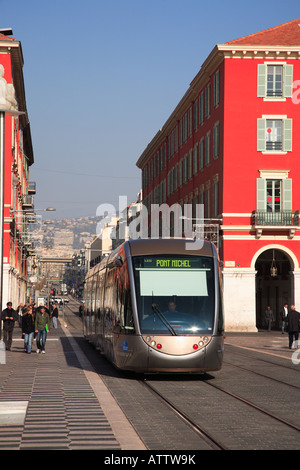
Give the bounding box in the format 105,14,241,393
252,210,299,238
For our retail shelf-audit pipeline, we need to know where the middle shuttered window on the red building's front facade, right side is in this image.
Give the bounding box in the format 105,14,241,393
257,116,292,153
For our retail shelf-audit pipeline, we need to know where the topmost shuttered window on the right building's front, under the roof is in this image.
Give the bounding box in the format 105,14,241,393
257,62,293,99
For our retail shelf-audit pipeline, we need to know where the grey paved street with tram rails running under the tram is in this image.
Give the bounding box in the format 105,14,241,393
64,301,300,450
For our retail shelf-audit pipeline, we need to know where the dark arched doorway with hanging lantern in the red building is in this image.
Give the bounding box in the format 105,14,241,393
255,248,294,329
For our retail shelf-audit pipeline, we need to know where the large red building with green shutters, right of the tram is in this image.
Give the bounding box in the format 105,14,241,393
137,19,300,331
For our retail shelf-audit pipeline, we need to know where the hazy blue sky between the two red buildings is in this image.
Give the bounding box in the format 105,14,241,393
0,0,300,219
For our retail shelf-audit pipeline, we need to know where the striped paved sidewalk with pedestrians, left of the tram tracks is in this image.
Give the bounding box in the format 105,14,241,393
0,326,145,450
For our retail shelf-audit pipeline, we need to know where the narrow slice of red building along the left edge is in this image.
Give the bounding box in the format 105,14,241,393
0,30,35,308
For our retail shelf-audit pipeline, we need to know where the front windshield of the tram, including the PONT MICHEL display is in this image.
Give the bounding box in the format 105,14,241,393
133,255,215,335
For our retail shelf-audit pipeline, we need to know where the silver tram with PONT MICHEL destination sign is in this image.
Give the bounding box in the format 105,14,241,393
83,239,224,373
